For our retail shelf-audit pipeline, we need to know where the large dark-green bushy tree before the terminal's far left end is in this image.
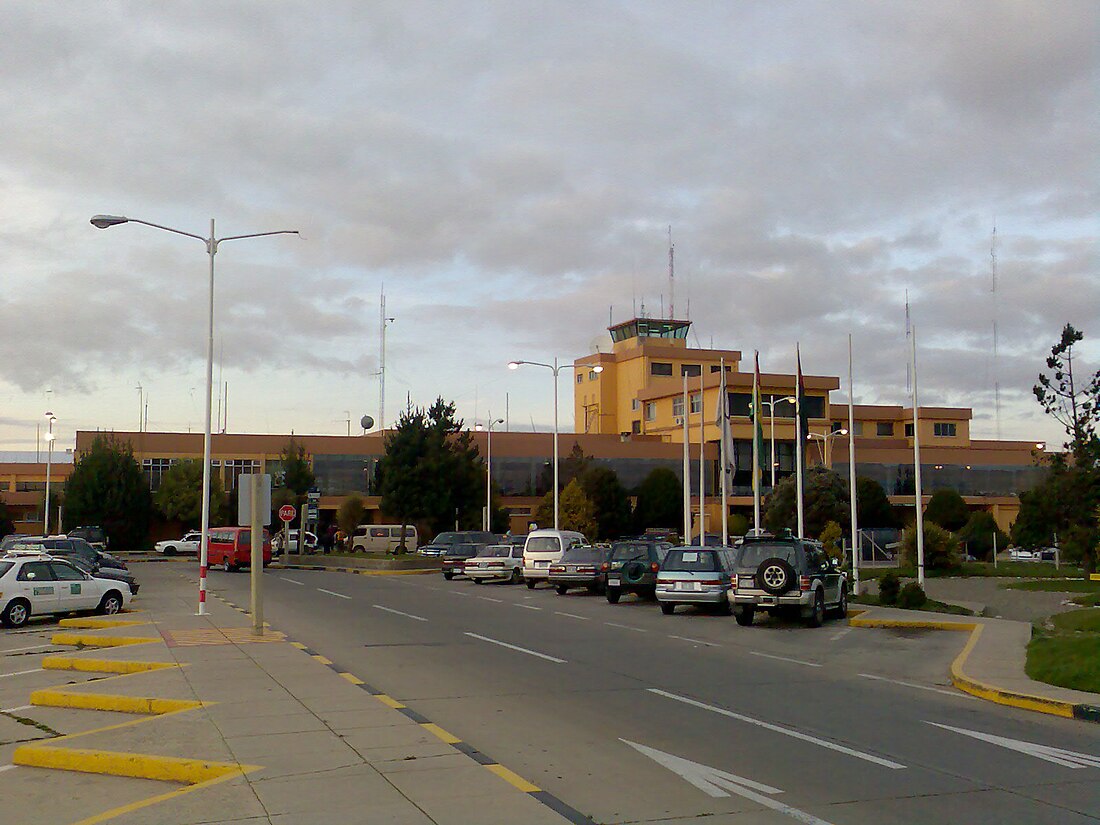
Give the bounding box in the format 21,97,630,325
65,433,153,550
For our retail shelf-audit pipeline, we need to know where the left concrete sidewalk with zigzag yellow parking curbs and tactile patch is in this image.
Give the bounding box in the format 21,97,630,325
0,564,585,825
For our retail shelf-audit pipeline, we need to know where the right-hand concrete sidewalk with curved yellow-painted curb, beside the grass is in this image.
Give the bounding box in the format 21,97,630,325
849,607,1100,722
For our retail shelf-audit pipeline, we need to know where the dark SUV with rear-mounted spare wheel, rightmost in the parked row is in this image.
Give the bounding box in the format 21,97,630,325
729,536,848,627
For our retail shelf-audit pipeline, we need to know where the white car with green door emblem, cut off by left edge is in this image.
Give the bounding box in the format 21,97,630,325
0,554,130,627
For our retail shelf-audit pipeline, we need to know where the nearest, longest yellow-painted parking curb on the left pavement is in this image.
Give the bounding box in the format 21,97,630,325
11,745,259,785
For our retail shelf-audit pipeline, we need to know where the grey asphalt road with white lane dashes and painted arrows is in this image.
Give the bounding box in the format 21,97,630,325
209,570,1100,825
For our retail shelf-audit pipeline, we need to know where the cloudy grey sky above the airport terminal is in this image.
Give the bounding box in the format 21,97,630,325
0,0,1100,450
